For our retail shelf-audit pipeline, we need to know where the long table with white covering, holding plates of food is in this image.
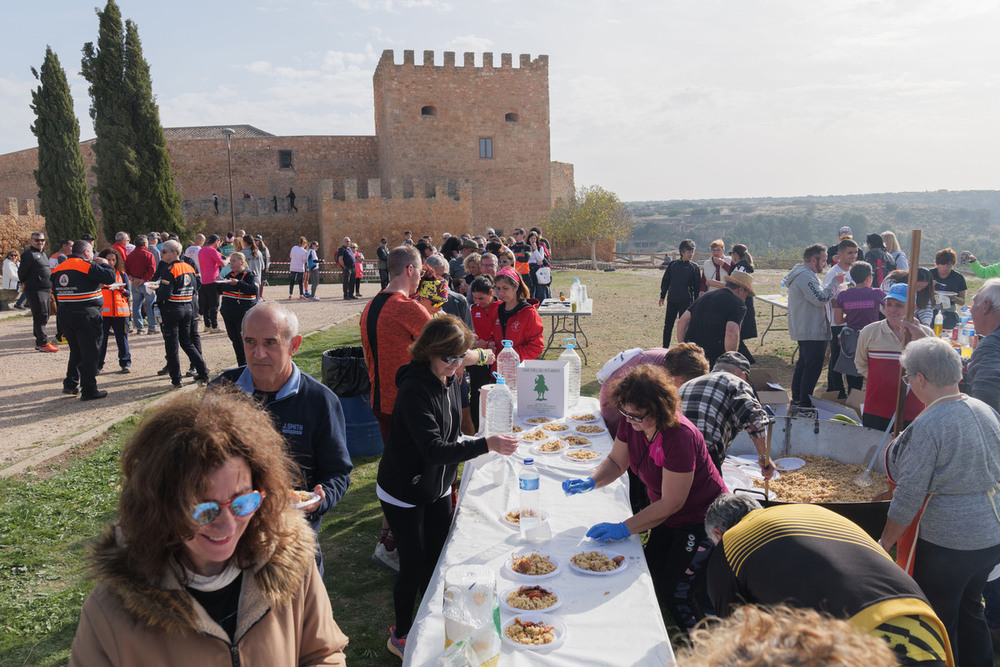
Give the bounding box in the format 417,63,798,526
403,397,675,666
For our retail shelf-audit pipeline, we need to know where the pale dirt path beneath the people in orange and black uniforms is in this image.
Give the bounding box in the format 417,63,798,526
0,285,374,475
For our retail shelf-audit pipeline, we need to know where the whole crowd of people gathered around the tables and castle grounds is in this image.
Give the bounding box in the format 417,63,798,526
4,222,1000,665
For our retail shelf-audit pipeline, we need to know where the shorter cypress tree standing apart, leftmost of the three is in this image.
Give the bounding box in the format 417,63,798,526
31,47,97,248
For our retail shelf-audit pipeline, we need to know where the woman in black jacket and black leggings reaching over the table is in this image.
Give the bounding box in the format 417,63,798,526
376,315,517,657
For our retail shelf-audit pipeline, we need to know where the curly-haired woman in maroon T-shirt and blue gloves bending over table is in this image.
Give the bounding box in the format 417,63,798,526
563,364,726,630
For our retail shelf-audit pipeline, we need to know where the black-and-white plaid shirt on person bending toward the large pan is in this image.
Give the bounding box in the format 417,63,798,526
677,372,768,466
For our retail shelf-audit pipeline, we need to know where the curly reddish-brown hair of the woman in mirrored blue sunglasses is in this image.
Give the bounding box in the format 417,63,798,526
118,388,300,578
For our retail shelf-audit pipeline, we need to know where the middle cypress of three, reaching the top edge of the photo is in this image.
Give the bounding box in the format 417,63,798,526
81,0,139,241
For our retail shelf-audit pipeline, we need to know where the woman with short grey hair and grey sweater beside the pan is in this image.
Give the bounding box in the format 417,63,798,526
879,338,1000,665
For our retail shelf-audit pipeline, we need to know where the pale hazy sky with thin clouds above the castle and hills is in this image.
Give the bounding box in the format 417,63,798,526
0,0,1000,200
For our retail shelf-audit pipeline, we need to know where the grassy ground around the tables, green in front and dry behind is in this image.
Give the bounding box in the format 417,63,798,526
0,270,982,666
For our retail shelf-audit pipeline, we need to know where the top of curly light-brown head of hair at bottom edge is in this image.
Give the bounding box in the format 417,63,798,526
677,605,897,667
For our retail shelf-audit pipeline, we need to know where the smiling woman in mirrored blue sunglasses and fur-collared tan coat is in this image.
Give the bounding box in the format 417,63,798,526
69,392,347,667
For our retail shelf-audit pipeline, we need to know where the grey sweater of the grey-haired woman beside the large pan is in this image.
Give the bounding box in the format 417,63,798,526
889,398,1000,551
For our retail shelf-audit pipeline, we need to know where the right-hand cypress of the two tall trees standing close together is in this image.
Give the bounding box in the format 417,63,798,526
123,21,184,239
